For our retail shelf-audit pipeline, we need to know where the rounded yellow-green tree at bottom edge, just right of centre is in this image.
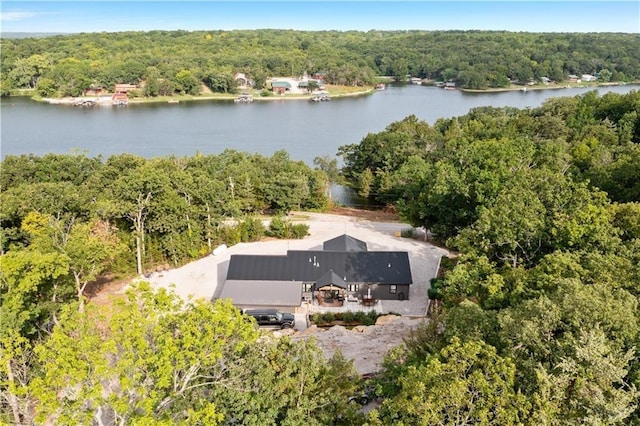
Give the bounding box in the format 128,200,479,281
371,338,530,425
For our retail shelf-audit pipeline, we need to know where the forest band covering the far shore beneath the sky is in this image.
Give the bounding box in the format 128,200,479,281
0,30,640,97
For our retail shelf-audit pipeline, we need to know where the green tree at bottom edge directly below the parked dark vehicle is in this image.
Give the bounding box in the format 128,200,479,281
212,338,364,426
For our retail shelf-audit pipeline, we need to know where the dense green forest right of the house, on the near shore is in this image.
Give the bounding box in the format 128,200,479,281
341,91,640,425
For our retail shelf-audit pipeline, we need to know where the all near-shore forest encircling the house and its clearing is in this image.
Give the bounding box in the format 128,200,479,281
0,91,640,425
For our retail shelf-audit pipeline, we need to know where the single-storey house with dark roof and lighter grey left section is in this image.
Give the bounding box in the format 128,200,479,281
220,235,413,312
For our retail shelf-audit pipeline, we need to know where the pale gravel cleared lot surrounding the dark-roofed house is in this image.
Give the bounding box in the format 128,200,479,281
141,213,447,374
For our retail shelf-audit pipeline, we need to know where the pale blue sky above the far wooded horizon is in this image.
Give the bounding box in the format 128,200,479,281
0,0,640,33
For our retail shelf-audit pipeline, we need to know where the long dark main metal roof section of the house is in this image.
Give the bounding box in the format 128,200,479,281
227,250,412,284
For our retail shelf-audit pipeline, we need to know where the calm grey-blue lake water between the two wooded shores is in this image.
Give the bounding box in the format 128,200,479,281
0,85,638,164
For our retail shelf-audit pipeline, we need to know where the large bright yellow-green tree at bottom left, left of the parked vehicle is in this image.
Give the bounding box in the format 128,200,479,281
30,284,257,424
